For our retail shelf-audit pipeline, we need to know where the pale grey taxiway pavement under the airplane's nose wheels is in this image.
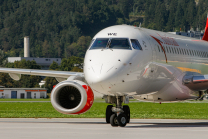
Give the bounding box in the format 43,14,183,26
0,118,208,139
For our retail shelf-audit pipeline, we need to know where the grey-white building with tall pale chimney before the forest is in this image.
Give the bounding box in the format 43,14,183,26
7,36,61,70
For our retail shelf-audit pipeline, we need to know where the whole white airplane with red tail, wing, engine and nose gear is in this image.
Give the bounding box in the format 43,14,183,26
0,17,208,127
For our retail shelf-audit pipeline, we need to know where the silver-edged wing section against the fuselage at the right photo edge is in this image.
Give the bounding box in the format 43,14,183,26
183,75,208,91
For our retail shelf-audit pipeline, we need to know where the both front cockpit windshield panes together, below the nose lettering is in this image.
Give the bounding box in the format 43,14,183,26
90,38,131,50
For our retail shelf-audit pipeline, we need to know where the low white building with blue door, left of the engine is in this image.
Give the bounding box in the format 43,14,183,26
0,88,47,99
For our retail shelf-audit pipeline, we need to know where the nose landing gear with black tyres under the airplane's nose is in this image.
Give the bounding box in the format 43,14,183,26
106,96,130,127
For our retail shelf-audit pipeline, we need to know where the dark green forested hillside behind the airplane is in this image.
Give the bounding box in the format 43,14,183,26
0,0,208,88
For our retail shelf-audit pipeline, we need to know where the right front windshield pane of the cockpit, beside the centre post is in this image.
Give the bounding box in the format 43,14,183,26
109,38,131,50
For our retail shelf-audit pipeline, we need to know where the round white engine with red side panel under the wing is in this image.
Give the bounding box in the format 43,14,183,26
51,80,94,114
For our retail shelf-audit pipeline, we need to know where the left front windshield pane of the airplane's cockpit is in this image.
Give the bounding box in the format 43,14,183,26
90,38,109,49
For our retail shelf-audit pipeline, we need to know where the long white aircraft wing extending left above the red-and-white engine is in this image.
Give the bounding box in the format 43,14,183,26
0,68,84,82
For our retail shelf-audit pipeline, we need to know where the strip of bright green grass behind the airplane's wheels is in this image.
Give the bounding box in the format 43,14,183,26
0,102,208,119
